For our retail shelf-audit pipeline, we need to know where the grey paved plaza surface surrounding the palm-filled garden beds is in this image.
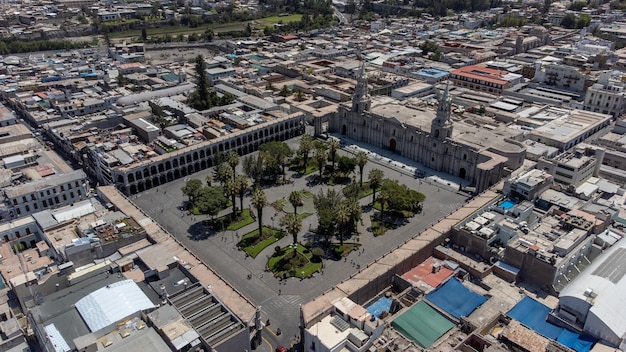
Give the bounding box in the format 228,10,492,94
131,133,467,350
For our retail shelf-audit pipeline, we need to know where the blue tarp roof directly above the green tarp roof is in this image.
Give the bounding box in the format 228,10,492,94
426,278,487,319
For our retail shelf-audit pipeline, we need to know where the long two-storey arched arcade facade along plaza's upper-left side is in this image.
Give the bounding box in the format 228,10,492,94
111,113,306,194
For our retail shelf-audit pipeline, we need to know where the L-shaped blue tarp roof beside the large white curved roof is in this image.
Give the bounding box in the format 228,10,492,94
508,296,596,352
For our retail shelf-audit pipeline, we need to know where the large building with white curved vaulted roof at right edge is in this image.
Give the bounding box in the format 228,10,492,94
553,235,626,350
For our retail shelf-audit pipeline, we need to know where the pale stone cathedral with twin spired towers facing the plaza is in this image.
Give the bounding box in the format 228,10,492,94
315,65,526,192
